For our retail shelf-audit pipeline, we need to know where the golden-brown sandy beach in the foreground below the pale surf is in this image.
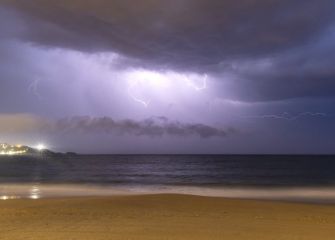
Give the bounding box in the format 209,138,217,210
0,194,335,240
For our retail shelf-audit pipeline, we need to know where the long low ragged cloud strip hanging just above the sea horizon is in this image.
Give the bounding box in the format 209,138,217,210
0,114,235,138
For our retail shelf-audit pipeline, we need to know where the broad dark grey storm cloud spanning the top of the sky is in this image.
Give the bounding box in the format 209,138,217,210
3,0,334,68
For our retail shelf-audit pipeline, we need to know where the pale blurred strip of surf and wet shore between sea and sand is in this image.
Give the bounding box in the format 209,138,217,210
0,183,335,204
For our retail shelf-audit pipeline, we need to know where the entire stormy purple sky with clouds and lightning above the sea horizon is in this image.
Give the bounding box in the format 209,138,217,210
0,0,335,154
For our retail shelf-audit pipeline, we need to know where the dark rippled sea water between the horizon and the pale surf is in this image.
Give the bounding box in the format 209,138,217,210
0,155,335,187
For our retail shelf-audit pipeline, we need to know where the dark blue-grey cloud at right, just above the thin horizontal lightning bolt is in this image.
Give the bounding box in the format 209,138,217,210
222,27,335,101
